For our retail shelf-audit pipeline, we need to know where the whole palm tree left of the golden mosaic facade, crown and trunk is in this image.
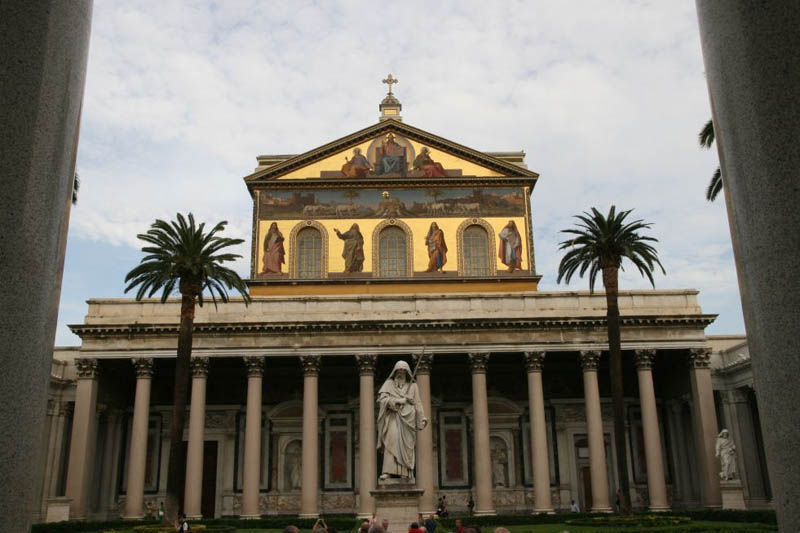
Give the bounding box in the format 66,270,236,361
125,213,250,522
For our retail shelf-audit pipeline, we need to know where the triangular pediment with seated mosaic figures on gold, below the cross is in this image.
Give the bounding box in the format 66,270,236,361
245,120,538,185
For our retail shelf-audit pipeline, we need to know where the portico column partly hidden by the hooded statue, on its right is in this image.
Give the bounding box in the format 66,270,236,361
416,354,436,516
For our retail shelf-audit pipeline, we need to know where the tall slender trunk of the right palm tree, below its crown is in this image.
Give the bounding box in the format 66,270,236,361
603,266,631,514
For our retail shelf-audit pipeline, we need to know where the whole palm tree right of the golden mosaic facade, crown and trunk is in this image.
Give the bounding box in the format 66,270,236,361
557,205,666,514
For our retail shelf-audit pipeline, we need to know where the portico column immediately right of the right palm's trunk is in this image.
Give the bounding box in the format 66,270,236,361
636,349,669,511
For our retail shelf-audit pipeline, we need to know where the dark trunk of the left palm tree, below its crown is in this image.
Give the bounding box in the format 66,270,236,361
164,284,199,523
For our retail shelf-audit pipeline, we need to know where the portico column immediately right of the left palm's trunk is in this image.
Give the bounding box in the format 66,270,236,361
183,357,208,520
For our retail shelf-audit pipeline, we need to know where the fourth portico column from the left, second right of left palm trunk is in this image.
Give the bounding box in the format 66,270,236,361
241,357,264,519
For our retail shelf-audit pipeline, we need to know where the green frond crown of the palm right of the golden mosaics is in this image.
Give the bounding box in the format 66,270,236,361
556,205,666,292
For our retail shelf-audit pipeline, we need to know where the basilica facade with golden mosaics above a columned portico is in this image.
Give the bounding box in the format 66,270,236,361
36,92,770,521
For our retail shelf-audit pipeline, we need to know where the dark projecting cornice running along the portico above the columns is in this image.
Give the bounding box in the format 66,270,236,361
69,315,716,338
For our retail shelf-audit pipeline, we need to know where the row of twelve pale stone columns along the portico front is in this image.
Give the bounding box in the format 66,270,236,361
62,349,721,519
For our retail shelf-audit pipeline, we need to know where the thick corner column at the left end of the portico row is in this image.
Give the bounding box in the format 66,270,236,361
66,359,97,520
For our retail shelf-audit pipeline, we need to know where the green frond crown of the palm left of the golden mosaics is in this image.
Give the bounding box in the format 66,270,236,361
125,213,250,306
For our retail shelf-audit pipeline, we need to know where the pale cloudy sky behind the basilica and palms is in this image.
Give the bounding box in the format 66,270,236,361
56,0,744,345
